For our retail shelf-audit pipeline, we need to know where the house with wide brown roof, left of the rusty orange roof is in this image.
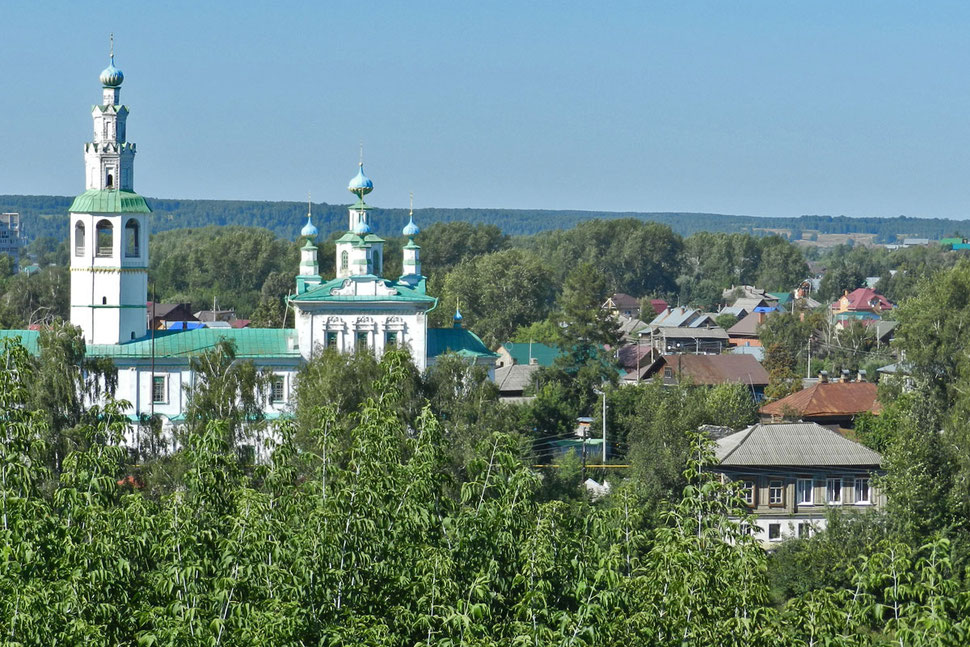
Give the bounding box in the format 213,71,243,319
640,355,768,400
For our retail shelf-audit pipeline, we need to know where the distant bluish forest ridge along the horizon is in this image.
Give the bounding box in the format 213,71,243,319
0,195,970,243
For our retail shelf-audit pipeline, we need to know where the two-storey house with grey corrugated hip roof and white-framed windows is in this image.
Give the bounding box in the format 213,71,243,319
713,422,885,548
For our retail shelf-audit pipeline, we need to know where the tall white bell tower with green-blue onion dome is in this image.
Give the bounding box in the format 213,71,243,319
69,38,151,344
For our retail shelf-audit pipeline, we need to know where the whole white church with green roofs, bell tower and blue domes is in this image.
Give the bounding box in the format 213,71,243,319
0,48,496,438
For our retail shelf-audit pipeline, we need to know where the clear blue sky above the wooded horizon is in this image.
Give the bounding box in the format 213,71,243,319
0,0,970,219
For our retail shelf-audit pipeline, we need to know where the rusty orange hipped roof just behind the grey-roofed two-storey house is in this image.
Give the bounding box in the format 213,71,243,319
759,376,882,429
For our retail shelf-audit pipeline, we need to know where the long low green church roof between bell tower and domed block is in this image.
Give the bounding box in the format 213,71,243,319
0,328,300,359
